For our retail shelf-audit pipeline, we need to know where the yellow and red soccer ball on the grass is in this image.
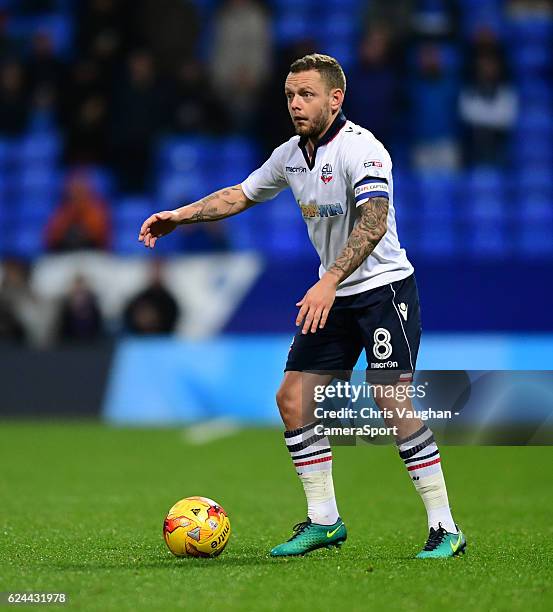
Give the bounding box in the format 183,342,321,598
163,497,230,557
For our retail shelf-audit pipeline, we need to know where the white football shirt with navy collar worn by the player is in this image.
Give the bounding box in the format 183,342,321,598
242,113,413,296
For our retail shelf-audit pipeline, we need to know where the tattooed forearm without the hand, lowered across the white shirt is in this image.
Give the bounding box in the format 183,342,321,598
329,198,388,283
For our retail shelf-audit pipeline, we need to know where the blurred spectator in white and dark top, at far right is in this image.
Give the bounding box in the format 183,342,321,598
459,45,518,165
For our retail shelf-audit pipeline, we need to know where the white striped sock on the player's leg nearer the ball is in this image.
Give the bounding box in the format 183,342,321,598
284,422,339,525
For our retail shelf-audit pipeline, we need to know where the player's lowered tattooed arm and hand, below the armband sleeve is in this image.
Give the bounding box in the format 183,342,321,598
296,197,388,334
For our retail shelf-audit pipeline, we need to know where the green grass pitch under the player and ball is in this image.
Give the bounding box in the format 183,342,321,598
0,423,553,612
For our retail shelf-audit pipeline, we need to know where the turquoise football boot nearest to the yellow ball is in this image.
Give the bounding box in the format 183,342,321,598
270,518,348,557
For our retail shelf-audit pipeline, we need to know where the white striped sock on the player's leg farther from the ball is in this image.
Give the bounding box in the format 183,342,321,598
396,425,457,533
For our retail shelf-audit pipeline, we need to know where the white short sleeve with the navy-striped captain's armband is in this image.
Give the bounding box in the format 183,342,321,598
346,138,392,206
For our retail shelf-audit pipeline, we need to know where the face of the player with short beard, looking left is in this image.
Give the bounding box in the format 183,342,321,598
284,70,336,138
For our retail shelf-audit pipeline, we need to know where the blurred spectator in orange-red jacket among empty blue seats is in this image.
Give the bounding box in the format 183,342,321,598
46,172,111,252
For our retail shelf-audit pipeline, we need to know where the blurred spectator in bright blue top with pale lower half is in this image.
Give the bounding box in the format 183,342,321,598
410,43,459,170
